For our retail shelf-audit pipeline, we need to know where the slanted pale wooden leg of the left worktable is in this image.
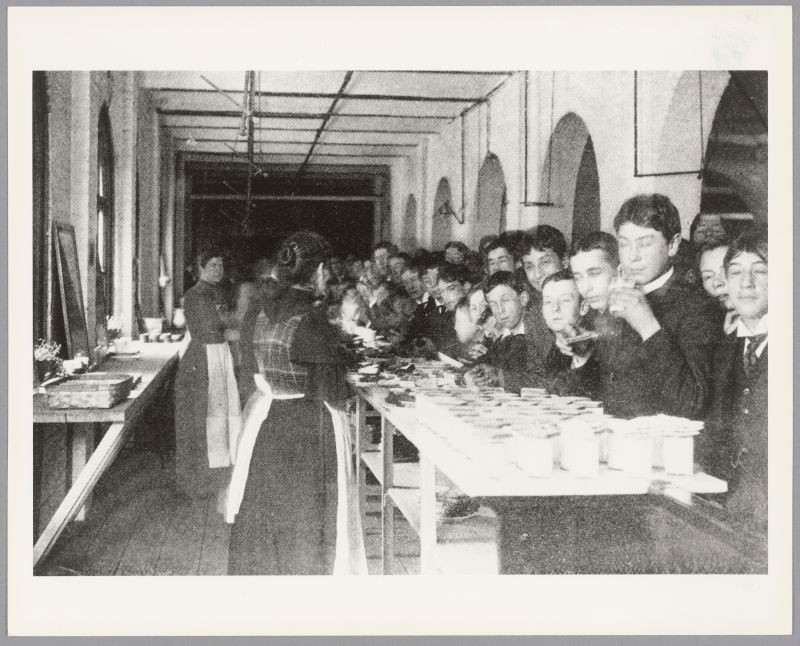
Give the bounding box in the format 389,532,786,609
33,422,130,567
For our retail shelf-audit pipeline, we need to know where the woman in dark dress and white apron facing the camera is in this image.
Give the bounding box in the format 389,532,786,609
175,249,241,498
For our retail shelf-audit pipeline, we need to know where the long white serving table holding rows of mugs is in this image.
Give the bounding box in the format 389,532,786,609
348,374,740,574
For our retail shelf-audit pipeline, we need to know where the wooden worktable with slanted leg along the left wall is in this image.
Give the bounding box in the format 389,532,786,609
33,343,185,567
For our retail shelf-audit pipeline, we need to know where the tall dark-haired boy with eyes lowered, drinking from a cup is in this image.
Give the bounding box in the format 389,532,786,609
604,194,722,419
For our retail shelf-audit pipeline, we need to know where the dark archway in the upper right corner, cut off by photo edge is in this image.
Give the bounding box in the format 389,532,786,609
700,72,767,224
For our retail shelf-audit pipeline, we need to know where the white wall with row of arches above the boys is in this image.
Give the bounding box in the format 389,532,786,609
393,71,728,251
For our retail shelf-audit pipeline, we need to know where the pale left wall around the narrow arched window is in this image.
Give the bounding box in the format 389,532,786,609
47,71,161,347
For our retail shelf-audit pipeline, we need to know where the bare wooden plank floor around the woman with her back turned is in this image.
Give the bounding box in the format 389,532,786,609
36,448,419,576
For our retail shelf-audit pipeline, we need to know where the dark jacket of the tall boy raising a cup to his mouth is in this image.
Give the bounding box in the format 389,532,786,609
595,275,722,419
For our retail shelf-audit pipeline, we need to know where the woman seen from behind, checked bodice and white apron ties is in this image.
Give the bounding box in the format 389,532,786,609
226,232,366,574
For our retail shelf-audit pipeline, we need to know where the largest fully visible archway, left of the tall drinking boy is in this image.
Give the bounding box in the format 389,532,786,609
539,112,600,240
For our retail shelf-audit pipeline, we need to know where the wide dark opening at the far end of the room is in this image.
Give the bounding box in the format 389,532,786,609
183,159,391,280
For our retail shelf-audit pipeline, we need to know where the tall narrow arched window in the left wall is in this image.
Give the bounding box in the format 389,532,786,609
97,104,114,318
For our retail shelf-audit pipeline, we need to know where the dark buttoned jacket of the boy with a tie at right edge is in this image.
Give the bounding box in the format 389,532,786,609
698,334,769,527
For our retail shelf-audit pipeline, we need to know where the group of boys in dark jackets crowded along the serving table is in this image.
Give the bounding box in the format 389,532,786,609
364,194,768,527
